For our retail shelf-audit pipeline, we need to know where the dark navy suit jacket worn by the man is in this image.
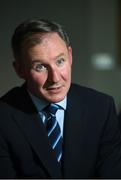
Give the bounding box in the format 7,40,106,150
0,85,121,179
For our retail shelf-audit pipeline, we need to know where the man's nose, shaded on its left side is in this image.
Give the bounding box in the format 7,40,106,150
48,67,60,83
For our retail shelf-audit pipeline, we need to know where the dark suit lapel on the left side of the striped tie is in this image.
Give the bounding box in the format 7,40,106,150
11,84,61,178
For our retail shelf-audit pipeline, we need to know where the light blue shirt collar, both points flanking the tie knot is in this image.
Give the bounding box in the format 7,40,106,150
28,91,67,112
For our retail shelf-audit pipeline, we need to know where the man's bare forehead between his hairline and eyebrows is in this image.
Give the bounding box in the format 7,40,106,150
24,33,67,59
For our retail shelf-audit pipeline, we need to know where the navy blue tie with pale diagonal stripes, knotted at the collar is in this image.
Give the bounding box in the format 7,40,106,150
45,104,62,162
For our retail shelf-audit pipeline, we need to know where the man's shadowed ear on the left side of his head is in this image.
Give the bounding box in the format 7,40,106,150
13,60,25,79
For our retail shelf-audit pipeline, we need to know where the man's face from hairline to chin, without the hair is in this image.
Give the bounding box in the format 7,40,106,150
15,33,72,103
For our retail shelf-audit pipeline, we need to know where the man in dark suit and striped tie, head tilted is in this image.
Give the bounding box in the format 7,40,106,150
0,19,121,179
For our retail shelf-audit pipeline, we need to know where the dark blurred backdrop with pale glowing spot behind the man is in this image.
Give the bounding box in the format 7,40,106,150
0,0,121,111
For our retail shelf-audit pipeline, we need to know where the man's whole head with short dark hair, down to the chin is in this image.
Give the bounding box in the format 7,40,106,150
12,19,72,102
